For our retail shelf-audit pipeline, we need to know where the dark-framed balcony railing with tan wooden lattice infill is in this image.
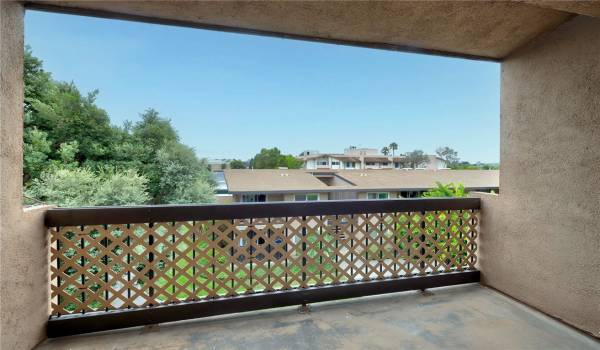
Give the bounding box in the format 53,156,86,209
46,198,480,336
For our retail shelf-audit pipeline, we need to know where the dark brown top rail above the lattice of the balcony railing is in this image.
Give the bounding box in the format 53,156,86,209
45,198,481,227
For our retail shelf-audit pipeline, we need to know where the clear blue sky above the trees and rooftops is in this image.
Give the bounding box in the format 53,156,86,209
25,11,500,162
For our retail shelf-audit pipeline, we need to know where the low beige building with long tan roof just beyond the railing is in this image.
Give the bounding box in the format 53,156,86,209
224,169,499,202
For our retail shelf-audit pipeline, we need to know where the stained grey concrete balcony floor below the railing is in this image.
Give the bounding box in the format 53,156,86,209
38,284,600,350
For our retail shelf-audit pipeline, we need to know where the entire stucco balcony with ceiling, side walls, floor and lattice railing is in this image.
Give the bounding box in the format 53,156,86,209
0,1,600,349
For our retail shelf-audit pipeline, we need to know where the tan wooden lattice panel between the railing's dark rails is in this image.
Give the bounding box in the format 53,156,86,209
50,210,478,316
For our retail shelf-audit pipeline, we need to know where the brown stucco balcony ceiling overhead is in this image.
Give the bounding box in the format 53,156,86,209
23,1,600,60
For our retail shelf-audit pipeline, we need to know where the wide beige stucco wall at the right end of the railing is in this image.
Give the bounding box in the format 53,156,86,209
480,16,600,337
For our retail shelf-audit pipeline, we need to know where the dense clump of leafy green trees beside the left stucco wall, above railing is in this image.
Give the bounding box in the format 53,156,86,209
23,48,214,205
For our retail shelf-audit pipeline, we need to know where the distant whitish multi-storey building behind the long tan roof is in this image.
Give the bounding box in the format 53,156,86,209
298,147,446,170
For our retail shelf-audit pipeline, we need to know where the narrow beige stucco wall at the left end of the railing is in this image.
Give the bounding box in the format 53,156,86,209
0,1,49,350
